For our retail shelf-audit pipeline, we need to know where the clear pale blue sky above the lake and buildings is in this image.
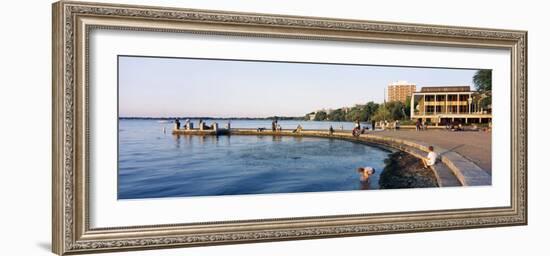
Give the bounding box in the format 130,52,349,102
118,56,477,118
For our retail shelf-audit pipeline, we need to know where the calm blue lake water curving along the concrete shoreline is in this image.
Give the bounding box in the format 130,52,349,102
118,120,389,199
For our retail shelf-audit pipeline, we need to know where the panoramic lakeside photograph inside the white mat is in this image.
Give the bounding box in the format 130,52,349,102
117,55,492,199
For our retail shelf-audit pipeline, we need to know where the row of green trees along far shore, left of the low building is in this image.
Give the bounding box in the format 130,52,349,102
304,98,410,122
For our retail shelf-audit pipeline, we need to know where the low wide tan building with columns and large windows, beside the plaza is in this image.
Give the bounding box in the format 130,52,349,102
411,86,492,125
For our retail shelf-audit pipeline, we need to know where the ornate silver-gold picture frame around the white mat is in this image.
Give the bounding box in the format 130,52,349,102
52,1,527,255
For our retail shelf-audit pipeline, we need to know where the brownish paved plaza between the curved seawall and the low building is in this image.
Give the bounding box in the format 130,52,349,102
374,130,491,174
